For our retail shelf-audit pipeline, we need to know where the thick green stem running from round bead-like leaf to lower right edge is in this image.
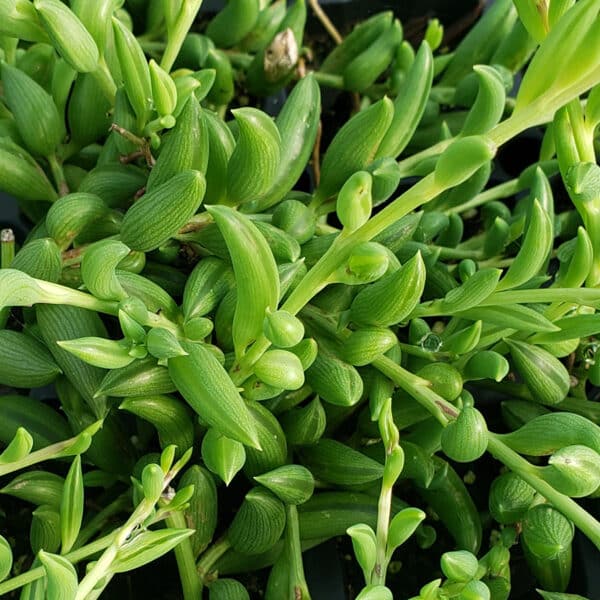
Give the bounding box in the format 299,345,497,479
488,432,600,549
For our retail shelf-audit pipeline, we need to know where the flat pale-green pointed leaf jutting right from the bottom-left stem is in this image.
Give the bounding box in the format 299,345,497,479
112,529,194,573
